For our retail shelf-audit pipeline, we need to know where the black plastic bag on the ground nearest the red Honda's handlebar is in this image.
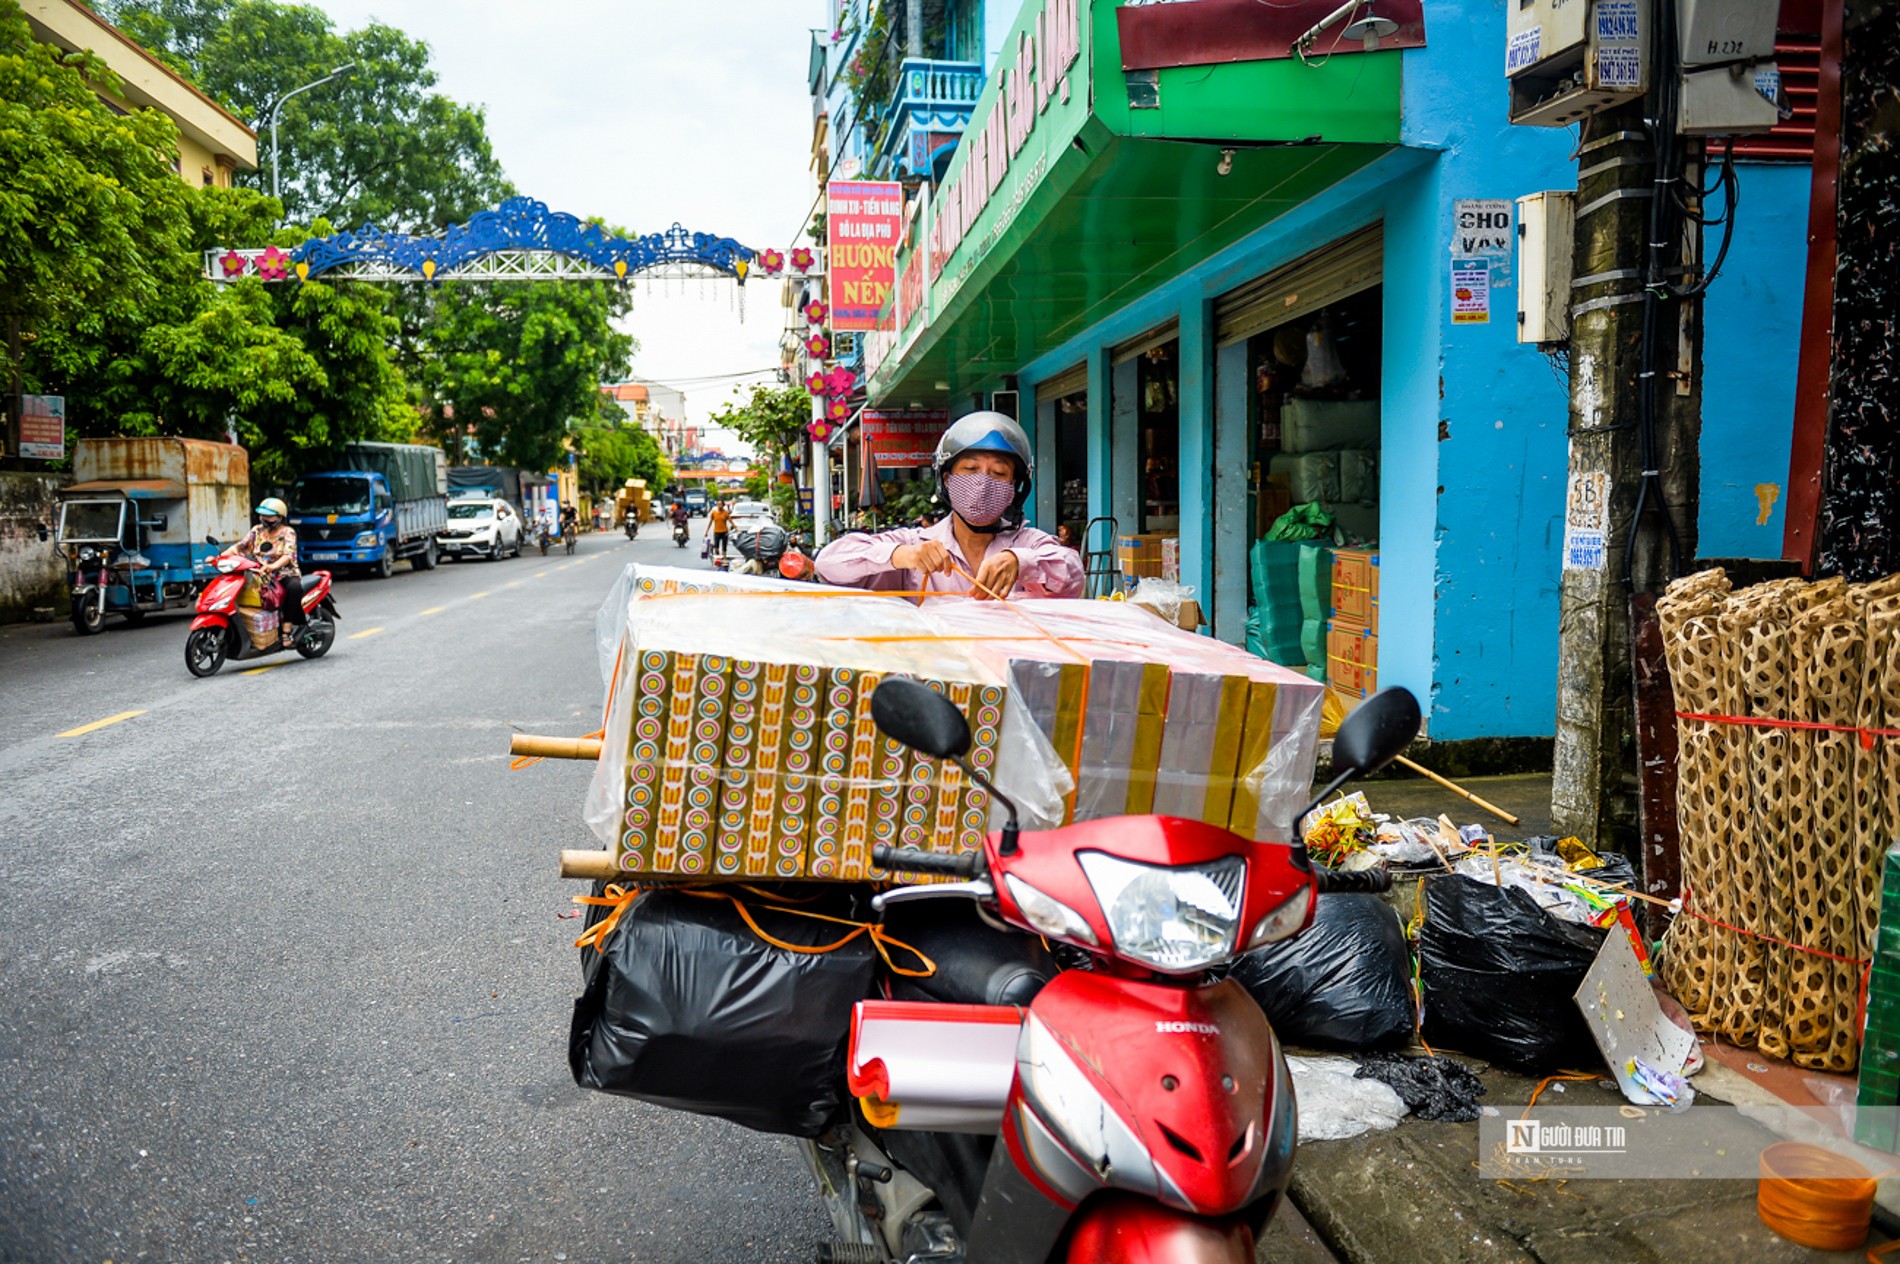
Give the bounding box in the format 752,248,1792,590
1229,895,1414,1053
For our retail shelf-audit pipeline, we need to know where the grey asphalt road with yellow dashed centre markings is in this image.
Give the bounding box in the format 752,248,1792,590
0,525,825,1264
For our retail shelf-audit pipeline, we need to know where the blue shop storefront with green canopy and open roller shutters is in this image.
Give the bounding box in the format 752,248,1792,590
866,0,1792,739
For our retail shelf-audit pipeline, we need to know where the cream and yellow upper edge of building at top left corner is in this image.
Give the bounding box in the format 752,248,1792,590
21,0,257,188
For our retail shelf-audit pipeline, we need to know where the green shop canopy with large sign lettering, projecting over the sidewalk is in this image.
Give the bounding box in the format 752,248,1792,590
868,0,1400,405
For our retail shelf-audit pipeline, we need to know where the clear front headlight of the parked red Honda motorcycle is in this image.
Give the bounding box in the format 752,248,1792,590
1079,852,1246,973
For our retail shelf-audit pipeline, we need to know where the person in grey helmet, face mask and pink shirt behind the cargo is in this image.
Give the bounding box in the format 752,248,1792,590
817,412,1081,601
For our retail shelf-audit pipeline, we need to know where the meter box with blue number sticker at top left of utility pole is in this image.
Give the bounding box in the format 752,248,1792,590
1505,0,1653,127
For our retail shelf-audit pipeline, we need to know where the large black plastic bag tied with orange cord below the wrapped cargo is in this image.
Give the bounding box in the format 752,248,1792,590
568,891,874,1137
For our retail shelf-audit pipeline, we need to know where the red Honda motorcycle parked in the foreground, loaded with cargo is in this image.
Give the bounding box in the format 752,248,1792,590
806,677,1419,1264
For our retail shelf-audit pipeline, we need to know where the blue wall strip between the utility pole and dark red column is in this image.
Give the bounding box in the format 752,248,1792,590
1697,163,1813,557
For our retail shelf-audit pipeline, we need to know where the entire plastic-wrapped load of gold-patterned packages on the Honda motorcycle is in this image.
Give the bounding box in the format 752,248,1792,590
587,568,1321,880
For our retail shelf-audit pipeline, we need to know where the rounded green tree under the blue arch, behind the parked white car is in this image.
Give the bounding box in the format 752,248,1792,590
414,281,633,469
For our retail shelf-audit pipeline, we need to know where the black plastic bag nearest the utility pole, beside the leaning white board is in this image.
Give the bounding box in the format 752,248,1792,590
1419,874,1604,1072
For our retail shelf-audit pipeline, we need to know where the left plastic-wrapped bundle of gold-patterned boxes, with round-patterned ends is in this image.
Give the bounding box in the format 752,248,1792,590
585,568,1072,880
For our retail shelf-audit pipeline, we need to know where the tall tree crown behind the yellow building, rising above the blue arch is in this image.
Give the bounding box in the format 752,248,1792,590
106,0,511,232
